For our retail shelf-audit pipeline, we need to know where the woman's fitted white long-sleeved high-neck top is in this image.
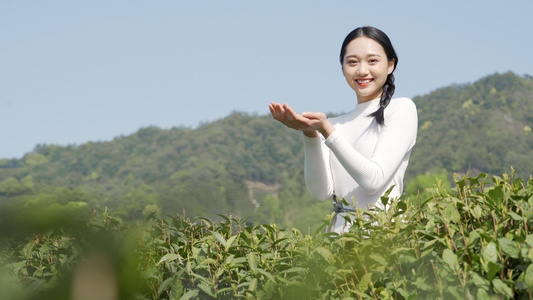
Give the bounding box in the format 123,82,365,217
304,98,418,223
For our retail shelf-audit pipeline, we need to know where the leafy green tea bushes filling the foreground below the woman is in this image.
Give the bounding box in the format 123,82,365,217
0,174,533,299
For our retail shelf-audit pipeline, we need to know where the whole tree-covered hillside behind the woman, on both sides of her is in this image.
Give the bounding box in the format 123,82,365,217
0,73,533,229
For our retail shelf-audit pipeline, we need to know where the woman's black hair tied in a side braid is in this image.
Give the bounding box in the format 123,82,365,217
340,26,398,125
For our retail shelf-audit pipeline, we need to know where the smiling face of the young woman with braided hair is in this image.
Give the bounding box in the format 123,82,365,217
342,36,394,103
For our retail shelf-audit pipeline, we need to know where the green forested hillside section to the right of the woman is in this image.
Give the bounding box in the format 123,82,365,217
406,72,533,182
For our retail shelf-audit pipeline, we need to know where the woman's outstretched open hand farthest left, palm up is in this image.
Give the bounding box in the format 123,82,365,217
268,102,318,137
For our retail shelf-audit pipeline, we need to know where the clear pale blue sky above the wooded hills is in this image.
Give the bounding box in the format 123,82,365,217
0,0,533,158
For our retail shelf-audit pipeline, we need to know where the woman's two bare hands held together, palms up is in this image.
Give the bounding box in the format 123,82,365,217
268,102,335,138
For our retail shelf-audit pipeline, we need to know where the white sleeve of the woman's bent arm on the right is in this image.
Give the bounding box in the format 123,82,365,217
325,98,418,194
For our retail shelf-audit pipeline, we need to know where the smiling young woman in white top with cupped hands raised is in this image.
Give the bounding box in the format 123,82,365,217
269,27,418,233
